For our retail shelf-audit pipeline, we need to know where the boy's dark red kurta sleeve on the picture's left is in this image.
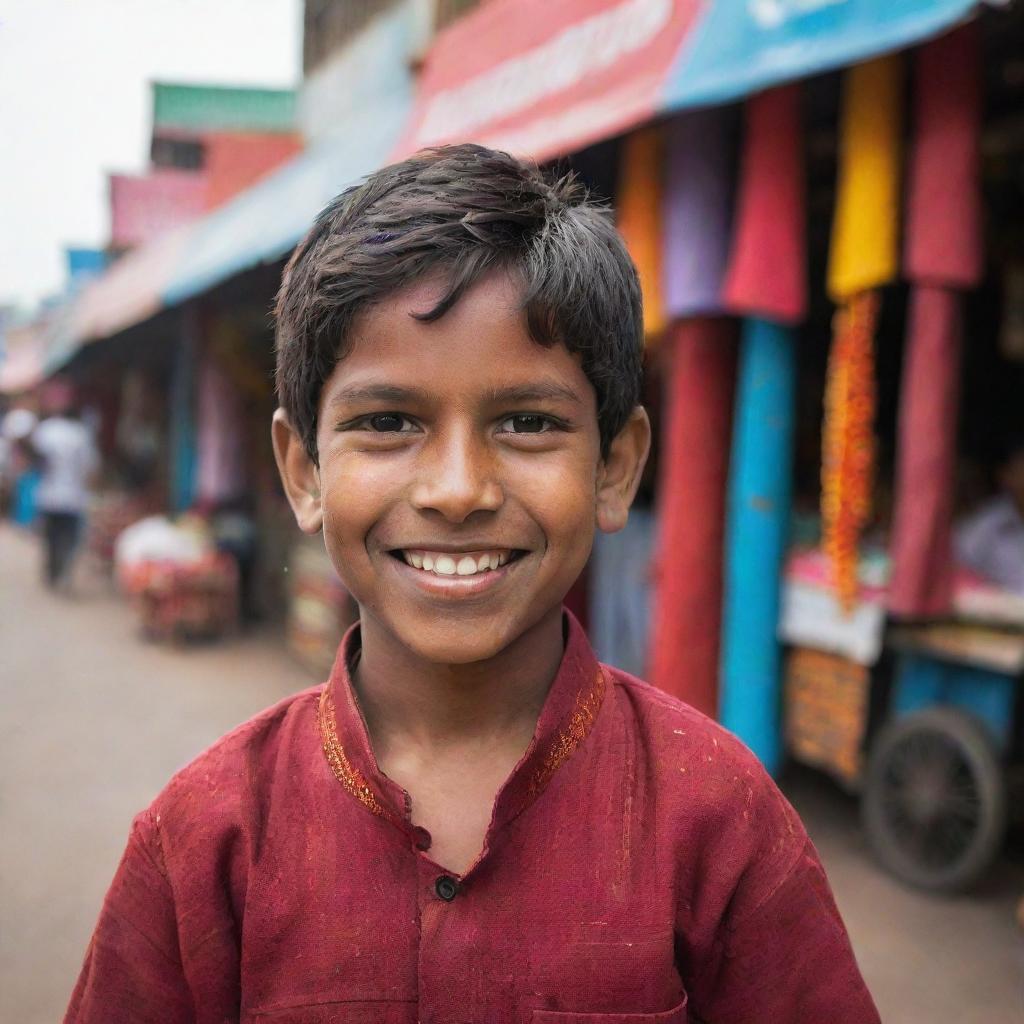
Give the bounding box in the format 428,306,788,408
65,811,196,1024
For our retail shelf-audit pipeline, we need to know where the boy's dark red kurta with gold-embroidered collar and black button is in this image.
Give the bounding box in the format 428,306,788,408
67,618,878,1024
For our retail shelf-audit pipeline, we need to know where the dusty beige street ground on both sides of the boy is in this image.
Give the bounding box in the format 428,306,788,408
0,525,1024,1024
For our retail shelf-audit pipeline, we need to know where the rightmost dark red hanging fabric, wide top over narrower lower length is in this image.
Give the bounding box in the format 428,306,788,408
889,24,984,616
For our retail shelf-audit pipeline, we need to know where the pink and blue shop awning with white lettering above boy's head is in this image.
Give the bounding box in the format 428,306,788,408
397,0,978,160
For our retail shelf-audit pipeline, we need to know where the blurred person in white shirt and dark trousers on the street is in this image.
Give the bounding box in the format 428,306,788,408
29,380,99,588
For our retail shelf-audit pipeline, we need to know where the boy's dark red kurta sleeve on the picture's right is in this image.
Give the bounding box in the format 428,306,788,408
691,839,879,1024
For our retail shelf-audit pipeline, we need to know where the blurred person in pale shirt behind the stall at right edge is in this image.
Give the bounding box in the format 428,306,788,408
955,434,1024,596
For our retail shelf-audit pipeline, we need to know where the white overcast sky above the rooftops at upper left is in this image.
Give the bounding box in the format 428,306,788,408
0,0,302,308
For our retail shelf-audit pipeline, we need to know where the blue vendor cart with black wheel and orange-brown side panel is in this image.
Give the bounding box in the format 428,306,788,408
781,548,1024,892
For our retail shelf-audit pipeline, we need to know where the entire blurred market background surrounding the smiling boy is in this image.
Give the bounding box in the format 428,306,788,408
0,0,1024,1024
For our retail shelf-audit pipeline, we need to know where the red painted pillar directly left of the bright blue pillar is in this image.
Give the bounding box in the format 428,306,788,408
648,316,736,718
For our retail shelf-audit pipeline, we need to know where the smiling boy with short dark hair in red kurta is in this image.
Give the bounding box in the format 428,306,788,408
68,145,878,1024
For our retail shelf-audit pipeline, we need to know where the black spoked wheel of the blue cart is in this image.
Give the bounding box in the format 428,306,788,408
861,708,1007,891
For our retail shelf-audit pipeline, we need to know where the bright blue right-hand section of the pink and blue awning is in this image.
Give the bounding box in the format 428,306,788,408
663,0,978,111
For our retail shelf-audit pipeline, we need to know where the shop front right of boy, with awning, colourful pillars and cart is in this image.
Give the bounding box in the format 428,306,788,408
398,0,1024,888
